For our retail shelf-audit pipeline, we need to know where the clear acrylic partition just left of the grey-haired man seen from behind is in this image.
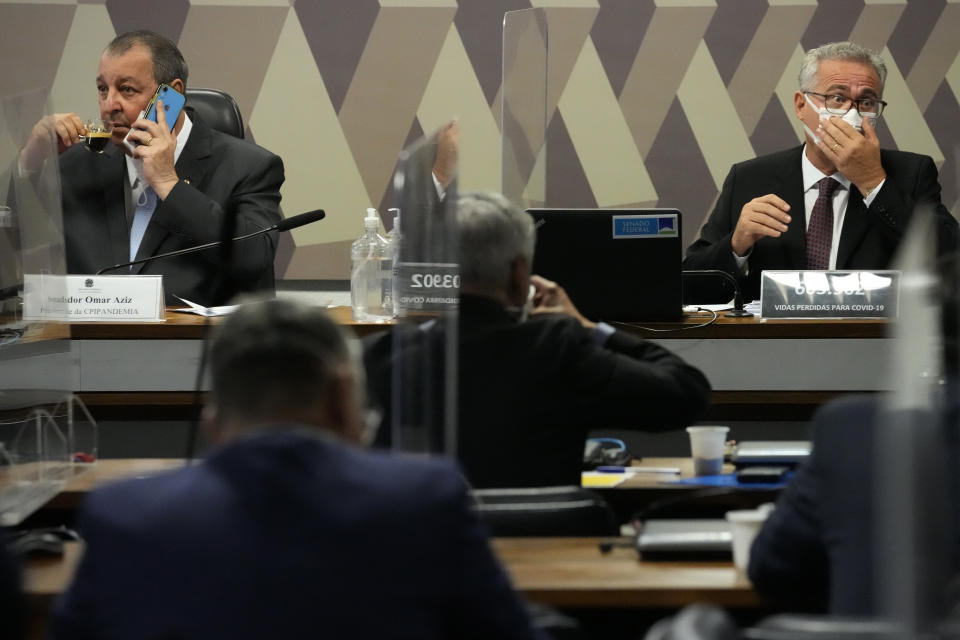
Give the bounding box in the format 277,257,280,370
386,126,459,455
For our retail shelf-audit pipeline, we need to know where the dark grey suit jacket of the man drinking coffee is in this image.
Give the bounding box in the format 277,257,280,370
60,116,283,305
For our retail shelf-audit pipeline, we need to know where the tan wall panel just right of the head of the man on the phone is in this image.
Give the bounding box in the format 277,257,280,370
180,6,286,114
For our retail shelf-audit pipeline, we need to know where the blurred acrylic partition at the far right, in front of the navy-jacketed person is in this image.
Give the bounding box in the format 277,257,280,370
873,213,960,638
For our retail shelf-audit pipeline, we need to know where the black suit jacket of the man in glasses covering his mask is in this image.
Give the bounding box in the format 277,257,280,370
683,146,958,302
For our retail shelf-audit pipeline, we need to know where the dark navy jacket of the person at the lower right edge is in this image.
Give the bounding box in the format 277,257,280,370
748,396,960,616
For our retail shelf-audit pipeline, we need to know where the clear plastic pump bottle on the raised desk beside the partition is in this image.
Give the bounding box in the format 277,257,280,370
350,209,393,322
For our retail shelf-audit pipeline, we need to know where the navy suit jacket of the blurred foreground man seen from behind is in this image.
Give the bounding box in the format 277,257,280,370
52,428,533,640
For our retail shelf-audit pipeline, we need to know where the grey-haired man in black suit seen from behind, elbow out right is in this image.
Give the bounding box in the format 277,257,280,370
364,193,710,488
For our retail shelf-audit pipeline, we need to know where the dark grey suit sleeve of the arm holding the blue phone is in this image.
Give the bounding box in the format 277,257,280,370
157,146,284,278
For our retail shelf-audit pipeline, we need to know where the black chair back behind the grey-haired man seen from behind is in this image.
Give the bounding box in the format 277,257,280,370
473,486,620,538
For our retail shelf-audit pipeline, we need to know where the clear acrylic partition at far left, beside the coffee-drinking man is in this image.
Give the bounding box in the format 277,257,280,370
0,92,97,525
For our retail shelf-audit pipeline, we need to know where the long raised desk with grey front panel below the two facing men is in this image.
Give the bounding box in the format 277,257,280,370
0,307,888,421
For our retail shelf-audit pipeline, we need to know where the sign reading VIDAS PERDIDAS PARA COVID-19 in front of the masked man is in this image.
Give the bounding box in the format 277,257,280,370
760,271,900,319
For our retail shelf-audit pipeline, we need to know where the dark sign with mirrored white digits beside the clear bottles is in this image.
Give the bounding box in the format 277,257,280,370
393,262,460,317
